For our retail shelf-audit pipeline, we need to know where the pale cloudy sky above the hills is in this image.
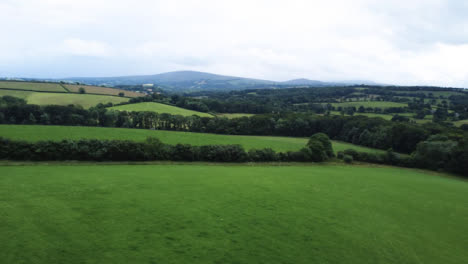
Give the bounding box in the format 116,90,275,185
0,0,468,87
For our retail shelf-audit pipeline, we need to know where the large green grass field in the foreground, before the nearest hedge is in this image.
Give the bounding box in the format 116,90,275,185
0,165,468,264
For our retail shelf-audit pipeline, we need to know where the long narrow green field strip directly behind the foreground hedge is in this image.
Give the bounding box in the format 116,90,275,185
0,125,383,153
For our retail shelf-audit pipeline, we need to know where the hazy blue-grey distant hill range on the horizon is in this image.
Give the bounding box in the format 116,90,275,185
44,71,380,91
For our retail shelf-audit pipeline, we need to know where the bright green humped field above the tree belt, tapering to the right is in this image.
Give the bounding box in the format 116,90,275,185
109,102,212,117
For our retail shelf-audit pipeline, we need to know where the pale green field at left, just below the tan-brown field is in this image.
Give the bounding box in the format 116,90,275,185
26,93,129,108
